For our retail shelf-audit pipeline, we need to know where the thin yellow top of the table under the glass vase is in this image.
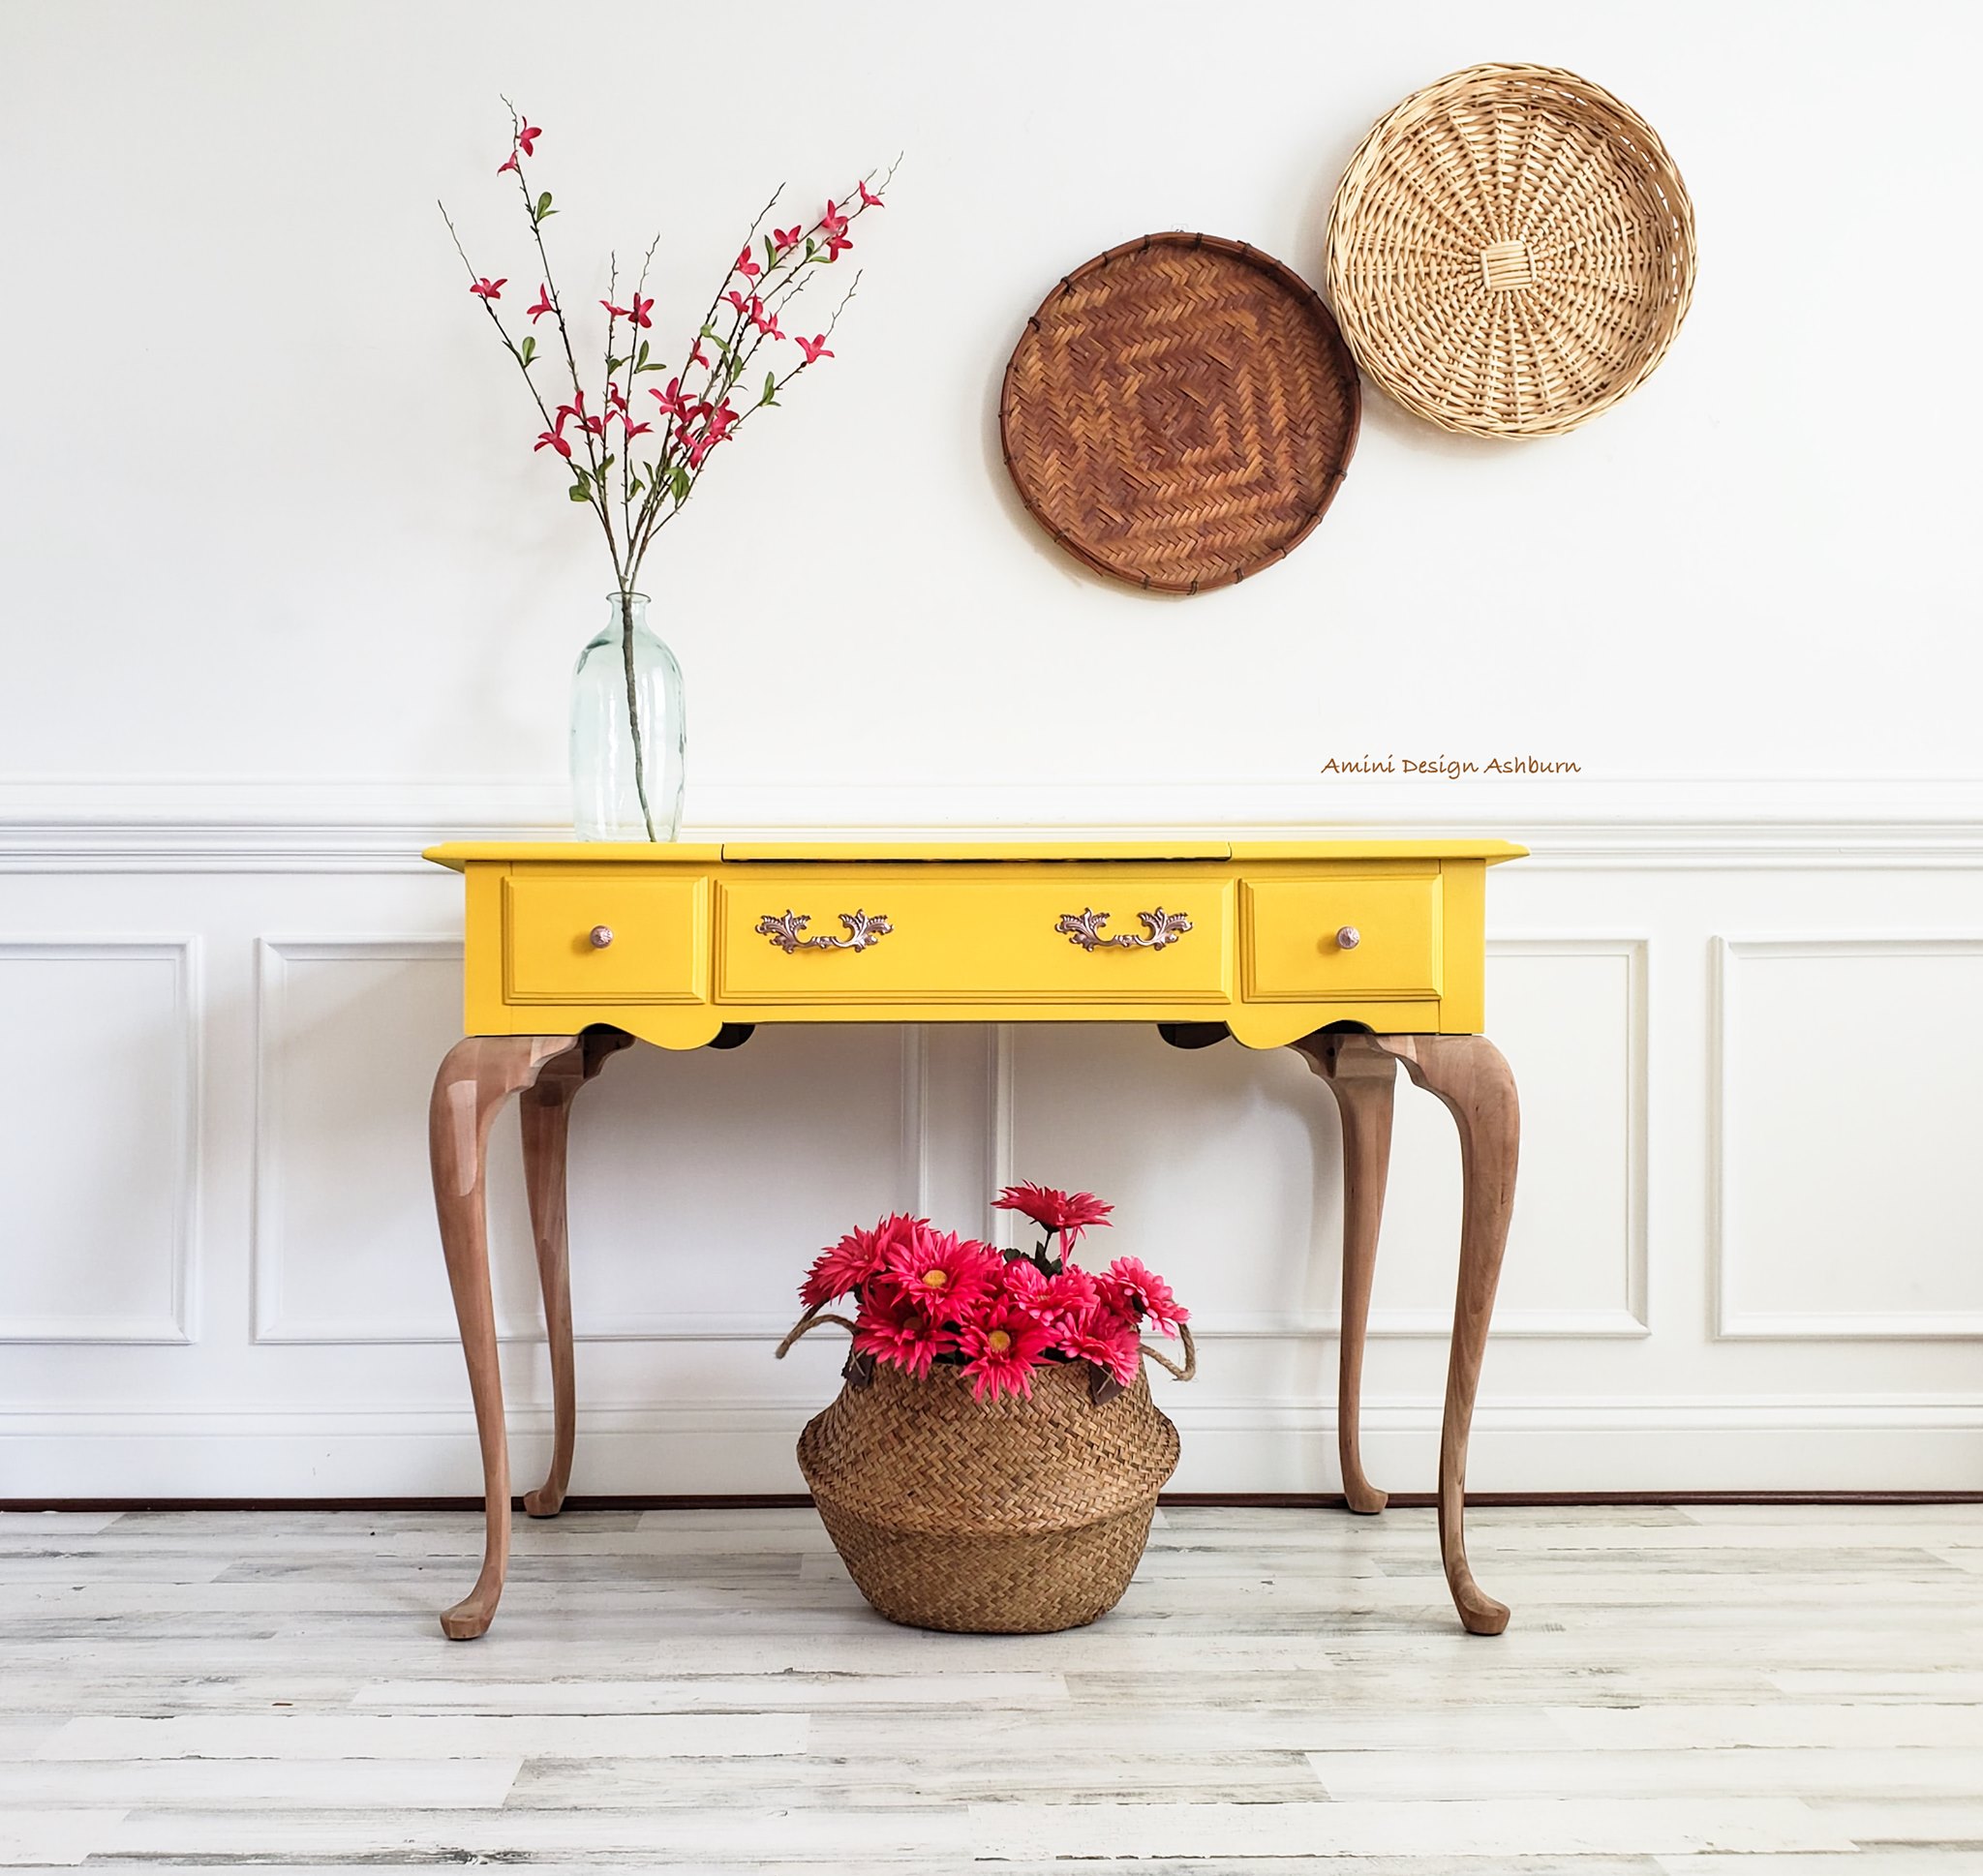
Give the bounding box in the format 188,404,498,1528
424,834,1529,872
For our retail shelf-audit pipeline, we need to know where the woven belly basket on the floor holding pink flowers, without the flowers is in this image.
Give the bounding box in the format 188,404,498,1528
799,1362,1178,1634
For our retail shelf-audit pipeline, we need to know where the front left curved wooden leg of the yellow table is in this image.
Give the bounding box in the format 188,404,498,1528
426,1035,577,1642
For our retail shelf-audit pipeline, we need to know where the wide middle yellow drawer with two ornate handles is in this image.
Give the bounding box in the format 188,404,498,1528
716,868,1234,1008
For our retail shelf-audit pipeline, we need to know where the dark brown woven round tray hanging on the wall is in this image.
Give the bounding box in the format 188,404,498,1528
997,234,1358,593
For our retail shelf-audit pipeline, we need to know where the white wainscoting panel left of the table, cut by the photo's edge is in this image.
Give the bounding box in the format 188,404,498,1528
0,934,200,1343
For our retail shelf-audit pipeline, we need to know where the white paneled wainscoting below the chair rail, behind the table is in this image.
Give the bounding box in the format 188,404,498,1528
0,825,1983,1499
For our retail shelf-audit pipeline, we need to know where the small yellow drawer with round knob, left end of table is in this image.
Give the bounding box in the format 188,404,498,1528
502,866,710,1004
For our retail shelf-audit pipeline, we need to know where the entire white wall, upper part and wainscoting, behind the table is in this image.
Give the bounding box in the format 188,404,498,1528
0,0,1983,1498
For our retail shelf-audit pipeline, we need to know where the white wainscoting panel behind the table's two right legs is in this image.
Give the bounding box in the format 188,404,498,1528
999,934,1648,1341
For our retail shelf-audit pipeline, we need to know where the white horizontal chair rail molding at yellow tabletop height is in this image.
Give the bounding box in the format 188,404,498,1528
0,775,1983,872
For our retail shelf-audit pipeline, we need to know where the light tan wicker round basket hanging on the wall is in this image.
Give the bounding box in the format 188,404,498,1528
1327,66,1695,437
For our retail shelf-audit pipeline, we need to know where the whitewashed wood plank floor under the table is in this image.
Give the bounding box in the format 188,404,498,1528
0,1507,1983,1876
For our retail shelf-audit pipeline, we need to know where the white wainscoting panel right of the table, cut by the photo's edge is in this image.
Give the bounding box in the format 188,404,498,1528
1716,934,1983,1341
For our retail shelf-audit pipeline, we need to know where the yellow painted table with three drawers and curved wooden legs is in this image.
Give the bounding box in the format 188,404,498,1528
426,841,1523,1640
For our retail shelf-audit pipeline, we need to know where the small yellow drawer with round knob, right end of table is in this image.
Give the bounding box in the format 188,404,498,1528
1243,868,1444,1004
